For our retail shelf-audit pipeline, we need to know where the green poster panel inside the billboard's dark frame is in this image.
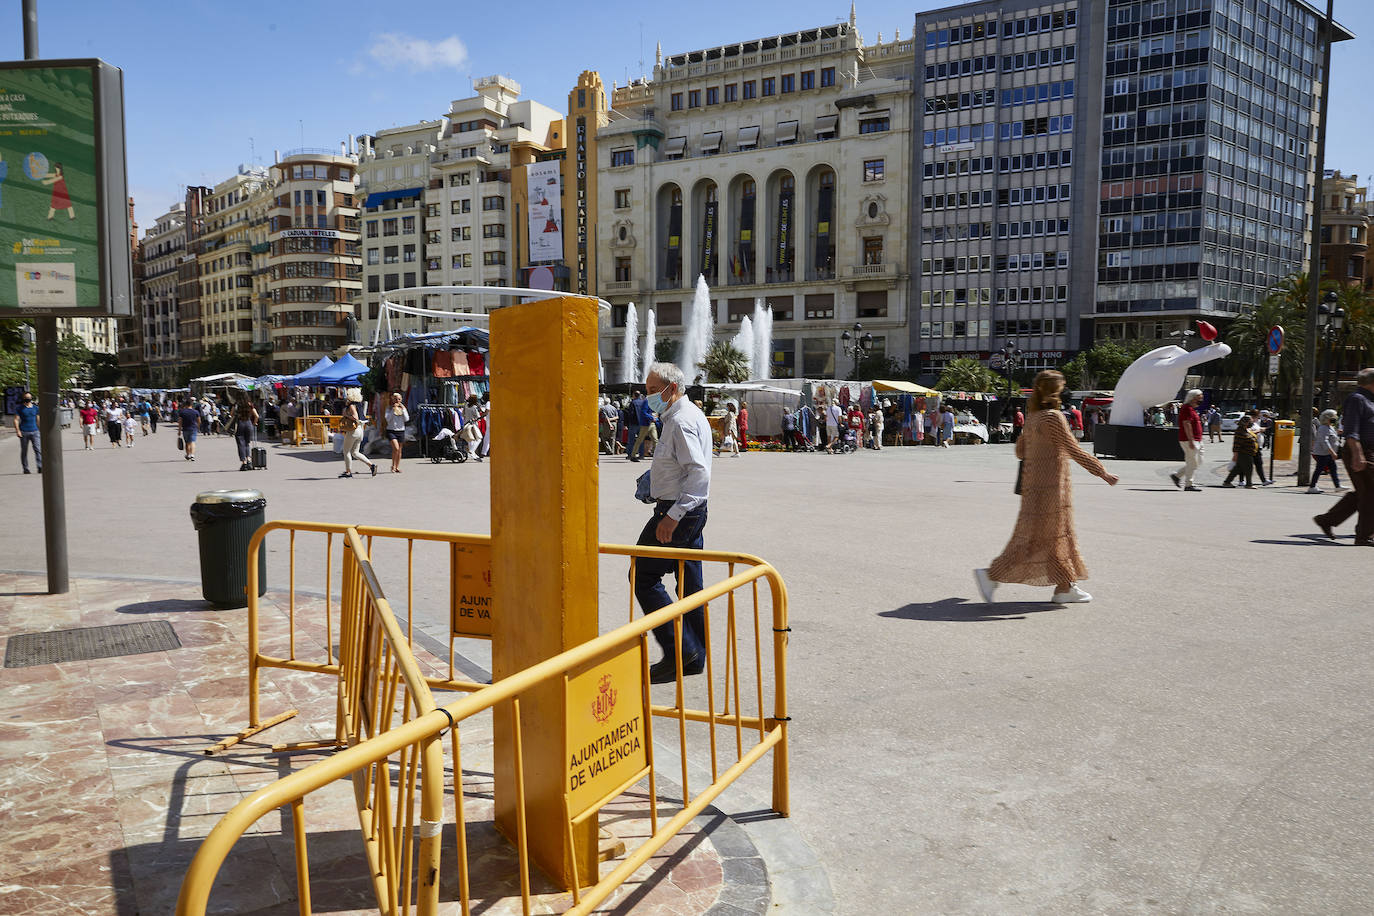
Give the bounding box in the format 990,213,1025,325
0,67,102,313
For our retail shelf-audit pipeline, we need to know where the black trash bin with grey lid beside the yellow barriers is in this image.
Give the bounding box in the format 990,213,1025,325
191,490,267,607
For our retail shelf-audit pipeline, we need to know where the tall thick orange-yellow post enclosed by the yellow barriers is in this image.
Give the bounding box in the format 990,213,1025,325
491,297,598,889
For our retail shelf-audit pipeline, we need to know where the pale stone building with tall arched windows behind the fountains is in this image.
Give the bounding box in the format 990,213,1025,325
596,18,914,378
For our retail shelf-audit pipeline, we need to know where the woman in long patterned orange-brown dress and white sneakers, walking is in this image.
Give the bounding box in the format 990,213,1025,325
973,369,1117,604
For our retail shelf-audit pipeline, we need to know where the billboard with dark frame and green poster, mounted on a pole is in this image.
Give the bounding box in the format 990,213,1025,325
0,59,132,317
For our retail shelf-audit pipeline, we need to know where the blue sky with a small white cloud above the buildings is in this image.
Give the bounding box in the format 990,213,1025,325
0,0,1374,236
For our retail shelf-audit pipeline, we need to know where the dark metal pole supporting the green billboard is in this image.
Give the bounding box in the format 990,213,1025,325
23,0,70,595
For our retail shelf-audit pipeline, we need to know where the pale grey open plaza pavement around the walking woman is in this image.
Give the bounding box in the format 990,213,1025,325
0,425,1374,915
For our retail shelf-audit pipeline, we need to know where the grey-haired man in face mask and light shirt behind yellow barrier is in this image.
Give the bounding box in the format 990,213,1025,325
635,363,712,684
